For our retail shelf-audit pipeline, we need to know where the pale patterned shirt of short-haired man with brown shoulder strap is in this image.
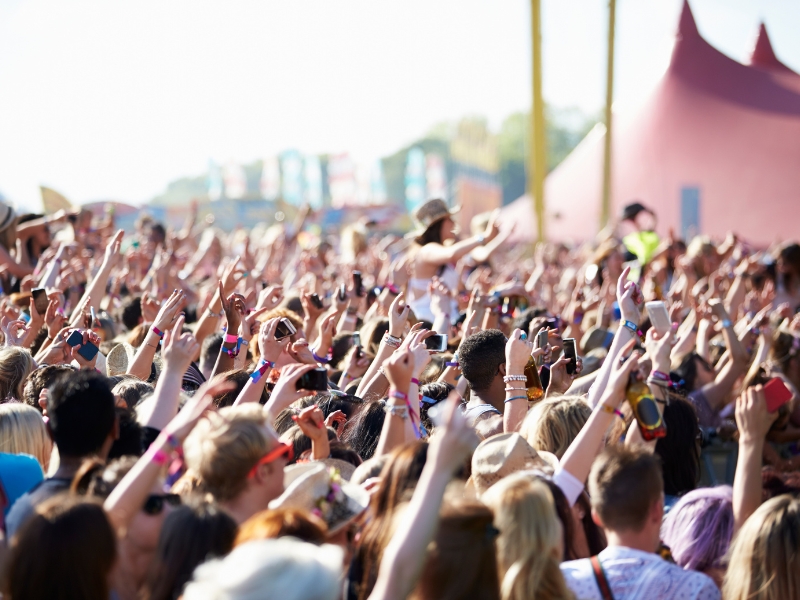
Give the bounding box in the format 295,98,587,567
561,546,722,600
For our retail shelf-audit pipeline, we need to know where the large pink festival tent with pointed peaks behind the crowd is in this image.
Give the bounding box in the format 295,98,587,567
503,3,800,244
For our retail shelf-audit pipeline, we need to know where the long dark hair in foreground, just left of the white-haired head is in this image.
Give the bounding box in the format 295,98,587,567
144,501,238,600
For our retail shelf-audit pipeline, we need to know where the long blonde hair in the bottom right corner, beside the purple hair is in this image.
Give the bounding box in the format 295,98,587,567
722,495,800,600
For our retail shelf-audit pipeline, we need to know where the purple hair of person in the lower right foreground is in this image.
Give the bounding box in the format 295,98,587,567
661,485,734,587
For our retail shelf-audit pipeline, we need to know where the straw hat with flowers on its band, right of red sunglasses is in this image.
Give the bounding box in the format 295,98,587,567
269,459,369,535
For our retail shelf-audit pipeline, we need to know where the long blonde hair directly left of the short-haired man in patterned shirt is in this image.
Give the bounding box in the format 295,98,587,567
481,473,572,600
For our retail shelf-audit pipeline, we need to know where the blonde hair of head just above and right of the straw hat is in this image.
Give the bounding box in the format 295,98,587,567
519,396,592,459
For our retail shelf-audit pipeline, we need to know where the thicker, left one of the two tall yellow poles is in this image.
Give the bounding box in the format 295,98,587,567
528,0,547,241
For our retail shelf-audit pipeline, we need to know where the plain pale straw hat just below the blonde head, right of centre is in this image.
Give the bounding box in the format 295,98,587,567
471,433,558,494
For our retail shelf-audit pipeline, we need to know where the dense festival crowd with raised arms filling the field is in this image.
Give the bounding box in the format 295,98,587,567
0,195,800,600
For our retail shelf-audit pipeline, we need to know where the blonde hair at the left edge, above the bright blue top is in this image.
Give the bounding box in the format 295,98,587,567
0,402,53,472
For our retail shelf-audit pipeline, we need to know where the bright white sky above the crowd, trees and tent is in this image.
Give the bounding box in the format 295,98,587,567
0,0,800,207
